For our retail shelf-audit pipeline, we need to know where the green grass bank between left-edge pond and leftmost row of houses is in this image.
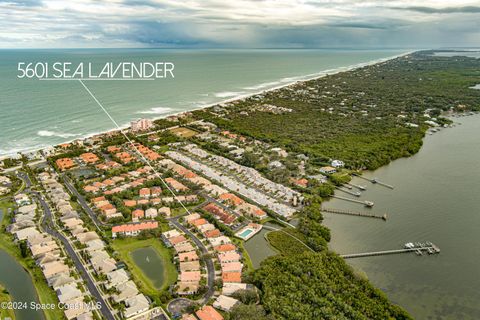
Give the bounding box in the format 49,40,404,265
0,202,64,320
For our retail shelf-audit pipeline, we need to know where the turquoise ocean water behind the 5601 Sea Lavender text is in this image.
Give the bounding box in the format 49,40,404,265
0,49,406,156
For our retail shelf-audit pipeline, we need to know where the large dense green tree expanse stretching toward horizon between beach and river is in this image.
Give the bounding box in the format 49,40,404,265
194,52,480,169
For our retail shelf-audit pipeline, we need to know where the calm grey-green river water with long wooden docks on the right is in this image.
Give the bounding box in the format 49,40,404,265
324,115,480,319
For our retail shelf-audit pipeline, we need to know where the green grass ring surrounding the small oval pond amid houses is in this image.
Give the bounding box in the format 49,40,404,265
112,238,177,297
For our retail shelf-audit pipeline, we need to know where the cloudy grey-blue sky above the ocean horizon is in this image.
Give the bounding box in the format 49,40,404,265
0,0,480,48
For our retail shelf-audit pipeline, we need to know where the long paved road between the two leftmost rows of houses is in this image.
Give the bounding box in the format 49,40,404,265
19,173,115,320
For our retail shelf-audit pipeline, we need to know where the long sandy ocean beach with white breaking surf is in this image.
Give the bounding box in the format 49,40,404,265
0,50,417,160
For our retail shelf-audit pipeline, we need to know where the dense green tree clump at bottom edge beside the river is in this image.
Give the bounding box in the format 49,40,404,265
251,252,411,320
